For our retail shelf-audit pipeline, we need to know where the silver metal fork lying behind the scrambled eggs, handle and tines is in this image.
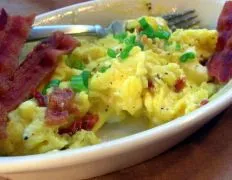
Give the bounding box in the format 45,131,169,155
28,9,200,41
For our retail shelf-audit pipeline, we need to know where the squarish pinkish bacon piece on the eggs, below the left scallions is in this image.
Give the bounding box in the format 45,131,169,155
45,88,74,125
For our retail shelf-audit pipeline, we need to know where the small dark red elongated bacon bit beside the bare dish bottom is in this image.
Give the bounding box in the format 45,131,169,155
59,113,99,135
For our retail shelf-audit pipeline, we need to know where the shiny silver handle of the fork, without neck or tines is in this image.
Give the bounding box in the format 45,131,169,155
27,25,106,41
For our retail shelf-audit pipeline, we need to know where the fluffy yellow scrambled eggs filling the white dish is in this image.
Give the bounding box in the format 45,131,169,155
0,17,219,155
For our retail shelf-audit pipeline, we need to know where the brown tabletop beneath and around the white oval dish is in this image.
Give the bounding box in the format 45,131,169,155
0,0,232,180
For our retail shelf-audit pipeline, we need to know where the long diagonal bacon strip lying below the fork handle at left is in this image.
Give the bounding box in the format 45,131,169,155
0,32,79,138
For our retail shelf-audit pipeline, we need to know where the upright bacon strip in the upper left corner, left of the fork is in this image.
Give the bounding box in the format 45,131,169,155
0,9,35,94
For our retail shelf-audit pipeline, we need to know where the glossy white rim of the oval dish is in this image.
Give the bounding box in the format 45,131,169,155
0,0,232,173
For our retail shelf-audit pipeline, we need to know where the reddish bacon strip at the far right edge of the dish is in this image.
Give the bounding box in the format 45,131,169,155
207,1,232,83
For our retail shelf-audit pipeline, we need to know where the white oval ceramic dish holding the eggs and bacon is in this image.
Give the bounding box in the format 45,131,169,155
0,0,232,180
